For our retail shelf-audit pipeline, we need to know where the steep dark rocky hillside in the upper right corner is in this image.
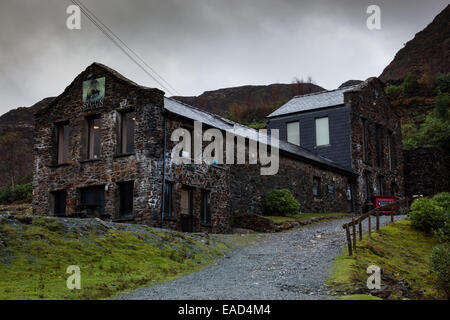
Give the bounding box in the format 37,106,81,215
380,5,450,84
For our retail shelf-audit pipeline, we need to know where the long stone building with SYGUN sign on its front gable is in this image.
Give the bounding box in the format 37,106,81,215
33,63,400,232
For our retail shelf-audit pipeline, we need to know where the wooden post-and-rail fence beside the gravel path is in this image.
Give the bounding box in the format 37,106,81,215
342,198,415,256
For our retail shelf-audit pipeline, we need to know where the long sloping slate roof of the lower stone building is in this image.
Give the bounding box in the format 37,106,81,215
164,97,357,175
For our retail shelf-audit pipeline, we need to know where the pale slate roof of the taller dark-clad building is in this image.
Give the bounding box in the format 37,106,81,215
267,84,361,118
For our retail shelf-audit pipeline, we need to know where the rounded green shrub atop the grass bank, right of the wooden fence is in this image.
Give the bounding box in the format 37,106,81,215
410,198,445,232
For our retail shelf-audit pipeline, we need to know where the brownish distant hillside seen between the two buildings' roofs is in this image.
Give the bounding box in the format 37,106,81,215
173,81,325,124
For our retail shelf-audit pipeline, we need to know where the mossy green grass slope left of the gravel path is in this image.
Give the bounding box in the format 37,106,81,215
0,217,239,299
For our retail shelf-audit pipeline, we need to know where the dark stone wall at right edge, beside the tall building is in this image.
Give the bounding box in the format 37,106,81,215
403,146,450,197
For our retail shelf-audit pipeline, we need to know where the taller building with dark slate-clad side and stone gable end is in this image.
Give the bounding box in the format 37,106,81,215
267,78,404,212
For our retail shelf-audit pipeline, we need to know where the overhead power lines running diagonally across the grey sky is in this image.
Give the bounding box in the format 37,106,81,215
71,0,178,95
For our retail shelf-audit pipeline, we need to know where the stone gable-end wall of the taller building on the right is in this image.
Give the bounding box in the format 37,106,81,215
344,78,405,211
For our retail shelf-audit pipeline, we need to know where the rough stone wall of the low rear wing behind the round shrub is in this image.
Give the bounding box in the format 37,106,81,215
230,153,351,216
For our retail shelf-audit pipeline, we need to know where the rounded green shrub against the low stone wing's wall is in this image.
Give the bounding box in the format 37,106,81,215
264,189,300,216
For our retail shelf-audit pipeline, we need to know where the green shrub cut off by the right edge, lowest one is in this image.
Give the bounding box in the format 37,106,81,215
430,243,450,299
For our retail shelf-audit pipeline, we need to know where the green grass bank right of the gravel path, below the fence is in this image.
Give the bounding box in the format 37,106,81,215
327,220,440,299
